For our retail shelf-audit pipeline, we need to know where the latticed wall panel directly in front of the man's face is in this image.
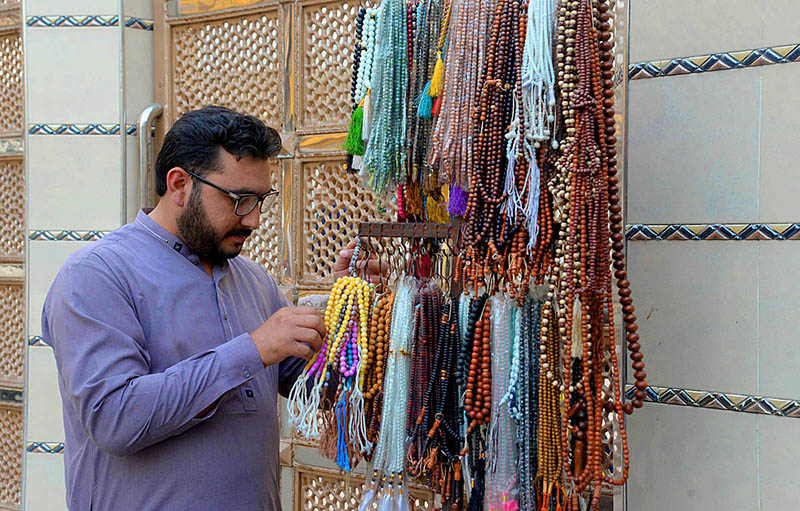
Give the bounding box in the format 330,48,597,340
243,161,283,279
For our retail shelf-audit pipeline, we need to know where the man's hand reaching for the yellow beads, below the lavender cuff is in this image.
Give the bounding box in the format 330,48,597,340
250,307,325,366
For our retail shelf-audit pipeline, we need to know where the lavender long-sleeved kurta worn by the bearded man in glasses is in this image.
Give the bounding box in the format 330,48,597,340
42,212,303,511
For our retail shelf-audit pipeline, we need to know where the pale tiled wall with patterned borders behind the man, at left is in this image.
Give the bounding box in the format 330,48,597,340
23,0,153,511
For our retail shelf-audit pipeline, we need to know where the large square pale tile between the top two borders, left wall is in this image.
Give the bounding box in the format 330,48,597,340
25,27,120,124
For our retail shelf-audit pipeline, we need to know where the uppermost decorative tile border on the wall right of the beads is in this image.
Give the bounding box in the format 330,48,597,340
628,44,800,80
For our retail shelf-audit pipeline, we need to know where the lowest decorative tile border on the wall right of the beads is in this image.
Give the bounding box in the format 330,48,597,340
625,385,800,418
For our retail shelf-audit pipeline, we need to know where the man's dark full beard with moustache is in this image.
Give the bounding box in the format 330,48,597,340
177,186,252,265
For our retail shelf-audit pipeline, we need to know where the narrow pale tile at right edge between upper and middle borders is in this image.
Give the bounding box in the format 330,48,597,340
758,64,800,223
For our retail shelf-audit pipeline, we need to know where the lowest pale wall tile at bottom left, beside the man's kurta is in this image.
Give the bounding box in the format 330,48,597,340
23,453,67,511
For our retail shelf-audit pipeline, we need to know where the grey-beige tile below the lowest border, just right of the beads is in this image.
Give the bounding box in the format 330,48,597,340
627,404,758,511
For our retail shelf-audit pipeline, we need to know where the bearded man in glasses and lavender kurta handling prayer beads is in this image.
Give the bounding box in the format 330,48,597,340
42,107,377,511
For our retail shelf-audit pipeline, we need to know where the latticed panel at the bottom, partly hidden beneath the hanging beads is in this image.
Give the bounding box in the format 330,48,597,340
294,467,433,511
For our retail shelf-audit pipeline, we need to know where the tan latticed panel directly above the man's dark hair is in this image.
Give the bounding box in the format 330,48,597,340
171,7,283,130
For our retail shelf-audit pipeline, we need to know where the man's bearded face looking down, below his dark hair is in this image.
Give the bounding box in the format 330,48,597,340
177,148,272,264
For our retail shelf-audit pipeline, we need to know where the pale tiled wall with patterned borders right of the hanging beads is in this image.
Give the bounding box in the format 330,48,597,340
626,0,800,511
